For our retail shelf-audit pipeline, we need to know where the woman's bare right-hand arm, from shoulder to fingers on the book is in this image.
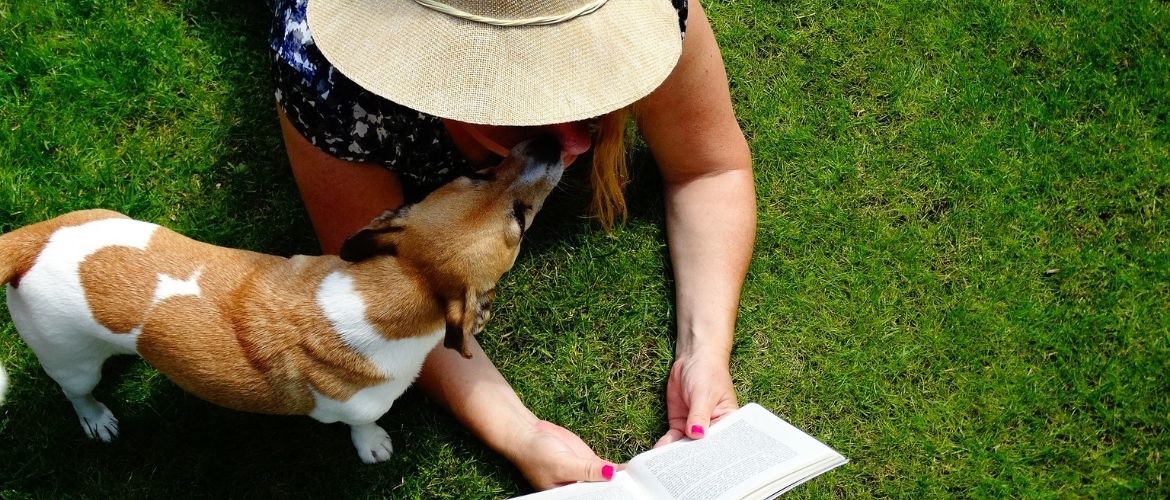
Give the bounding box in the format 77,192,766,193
635,1,756,444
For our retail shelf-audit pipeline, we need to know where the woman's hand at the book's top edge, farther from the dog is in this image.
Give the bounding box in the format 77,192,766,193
654,354,739,447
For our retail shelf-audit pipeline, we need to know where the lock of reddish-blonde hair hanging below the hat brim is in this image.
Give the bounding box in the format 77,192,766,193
590,108,631,233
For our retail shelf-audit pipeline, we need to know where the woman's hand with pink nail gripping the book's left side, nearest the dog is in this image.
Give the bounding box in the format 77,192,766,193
505,420,619,489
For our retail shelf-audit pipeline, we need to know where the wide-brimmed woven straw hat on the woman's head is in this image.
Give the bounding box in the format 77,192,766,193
308,0,682,125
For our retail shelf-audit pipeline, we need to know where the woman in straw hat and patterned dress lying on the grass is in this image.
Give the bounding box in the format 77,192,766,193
271,0,756,488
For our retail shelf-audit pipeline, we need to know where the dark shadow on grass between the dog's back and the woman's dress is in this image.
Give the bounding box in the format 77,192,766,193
162,0,319,255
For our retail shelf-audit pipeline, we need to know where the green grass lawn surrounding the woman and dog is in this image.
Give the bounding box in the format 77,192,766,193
0,0,1170,498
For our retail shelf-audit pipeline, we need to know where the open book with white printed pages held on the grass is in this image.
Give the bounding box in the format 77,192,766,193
521,403,848,500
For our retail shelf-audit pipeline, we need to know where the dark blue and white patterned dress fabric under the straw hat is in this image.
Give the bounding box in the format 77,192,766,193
269,0,687,197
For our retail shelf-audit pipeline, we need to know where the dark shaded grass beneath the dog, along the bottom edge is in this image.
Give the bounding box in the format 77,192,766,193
0,356,525,498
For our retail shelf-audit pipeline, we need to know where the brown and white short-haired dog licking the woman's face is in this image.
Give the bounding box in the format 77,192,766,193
0,139,564,464
